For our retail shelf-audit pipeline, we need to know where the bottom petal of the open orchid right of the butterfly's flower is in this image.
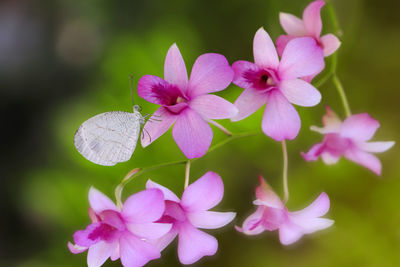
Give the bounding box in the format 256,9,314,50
262,90,301,141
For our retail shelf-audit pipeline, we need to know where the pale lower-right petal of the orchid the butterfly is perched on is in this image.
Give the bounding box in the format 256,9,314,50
189,95,238,119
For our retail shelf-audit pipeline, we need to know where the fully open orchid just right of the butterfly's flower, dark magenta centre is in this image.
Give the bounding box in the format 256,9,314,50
232,28,324,141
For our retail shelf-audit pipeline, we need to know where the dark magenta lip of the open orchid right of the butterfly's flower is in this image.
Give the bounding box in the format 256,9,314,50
232,60,262,89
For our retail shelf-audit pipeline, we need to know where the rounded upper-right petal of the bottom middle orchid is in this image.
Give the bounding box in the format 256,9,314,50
181,172,224,212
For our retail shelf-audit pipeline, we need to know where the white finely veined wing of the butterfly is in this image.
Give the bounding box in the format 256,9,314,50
74,111,141,166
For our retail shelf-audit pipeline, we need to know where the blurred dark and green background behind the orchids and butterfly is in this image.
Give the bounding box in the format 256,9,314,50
0,0,400,267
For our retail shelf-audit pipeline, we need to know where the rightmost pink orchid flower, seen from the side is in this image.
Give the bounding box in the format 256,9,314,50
302,106,395,175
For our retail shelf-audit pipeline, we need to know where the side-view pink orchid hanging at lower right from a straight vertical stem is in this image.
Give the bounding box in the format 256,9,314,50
236,176,333,245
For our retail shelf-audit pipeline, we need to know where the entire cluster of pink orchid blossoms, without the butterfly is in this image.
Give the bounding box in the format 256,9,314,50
68,0,394,267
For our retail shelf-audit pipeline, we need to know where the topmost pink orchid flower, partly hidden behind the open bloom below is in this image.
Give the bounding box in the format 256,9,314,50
276,0,340,57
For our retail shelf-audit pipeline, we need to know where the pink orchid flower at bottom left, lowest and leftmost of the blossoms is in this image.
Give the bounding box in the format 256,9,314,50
68,187,172,267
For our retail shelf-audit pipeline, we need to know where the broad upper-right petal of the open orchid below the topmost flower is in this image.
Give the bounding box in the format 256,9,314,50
279,37,325,80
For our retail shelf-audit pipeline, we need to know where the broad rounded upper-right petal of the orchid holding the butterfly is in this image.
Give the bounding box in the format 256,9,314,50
188,53,233,97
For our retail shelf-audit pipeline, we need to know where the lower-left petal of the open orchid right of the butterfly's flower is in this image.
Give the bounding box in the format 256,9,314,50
231,89,268,121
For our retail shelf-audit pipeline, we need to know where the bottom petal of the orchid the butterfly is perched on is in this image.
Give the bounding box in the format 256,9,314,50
172,108,213,159
